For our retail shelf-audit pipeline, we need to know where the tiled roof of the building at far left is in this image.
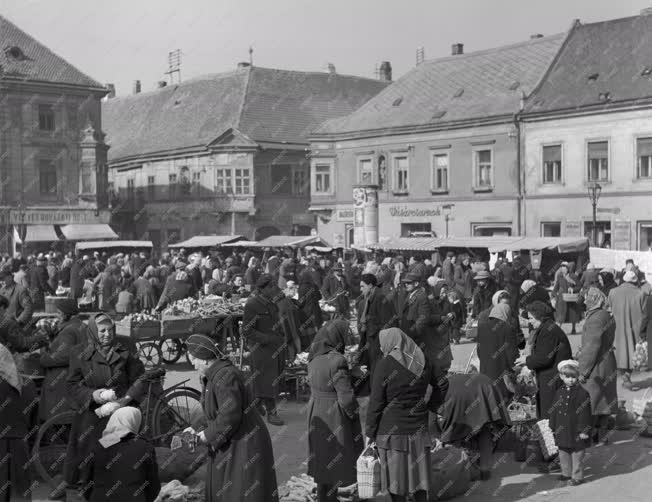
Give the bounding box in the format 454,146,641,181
0,16,103,88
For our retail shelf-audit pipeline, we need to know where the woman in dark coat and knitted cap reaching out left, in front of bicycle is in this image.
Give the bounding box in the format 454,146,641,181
186,335,278,502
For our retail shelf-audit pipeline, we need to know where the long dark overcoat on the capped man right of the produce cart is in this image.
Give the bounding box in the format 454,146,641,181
242,294,285,398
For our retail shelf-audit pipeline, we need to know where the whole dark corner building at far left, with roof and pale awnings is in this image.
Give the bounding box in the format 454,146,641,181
0,16,110,251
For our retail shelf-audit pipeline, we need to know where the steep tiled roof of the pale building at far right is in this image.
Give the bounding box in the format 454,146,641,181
525,15,652,113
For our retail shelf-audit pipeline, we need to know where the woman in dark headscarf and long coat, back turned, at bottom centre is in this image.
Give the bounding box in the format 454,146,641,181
308,320,363,502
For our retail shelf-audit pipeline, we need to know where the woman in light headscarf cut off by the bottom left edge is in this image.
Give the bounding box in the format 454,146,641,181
0,344,38,502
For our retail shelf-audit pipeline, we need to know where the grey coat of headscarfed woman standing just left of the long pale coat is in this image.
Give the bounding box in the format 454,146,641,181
579,309,618,415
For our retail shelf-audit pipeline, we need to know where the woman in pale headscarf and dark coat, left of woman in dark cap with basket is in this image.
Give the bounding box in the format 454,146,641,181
477,303,518,399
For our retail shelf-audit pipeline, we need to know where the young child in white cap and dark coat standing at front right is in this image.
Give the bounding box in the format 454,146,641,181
550,359,591,486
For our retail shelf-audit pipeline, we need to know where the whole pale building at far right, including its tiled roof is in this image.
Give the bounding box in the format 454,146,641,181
522,12,652,251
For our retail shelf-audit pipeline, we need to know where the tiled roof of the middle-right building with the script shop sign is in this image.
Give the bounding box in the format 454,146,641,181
315,34,565,136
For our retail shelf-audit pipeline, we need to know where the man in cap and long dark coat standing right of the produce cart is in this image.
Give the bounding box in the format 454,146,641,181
242,274,285,426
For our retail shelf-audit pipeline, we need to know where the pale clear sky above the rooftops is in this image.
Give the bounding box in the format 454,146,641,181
5,0,652,95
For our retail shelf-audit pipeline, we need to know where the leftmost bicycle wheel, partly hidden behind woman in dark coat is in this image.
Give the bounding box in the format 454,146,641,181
32,411,75,488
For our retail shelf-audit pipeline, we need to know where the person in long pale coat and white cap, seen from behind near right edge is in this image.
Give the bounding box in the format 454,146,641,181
609,270,646,389
